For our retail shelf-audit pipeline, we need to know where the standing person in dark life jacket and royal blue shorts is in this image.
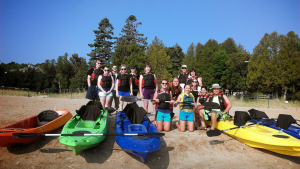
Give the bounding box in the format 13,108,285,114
116,64,132,110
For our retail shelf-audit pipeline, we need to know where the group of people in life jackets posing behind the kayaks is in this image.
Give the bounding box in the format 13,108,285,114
86,60,232,132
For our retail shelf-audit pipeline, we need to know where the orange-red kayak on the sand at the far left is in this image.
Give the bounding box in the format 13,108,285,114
0,110,72,147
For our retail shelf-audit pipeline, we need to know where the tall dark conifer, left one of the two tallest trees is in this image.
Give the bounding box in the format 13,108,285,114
87,18,116,63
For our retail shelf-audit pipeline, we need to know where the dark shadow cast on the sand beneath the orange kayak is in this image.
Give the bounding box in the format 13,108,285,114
7,127,64,155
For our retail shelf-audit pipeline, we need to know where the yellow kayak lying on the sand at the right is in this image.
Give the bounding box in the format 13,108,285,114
206,116,300,157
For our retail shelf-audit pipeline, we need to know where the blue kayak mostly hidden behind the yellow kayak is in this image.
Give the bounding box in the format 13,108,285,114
249,119,300,139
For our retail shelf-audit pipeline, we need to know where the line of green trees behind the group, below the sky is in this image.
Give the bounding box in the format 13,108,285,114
0,15,300,100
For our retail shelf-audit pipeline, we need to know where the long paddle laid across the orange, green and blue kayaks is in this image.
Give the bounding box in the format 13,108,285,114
11,132,165,138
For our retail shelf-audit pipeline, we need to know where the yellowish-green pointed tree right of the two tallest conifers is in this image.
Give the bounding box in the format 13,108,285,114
147,37,172,84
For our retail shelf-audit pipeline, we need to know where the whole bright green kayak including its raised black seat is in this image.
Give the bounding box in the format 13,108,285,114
59,101,108,155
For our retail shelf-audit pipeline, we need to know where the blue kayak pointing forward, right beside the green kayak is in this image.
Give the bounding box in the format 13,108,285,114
115,112,161,162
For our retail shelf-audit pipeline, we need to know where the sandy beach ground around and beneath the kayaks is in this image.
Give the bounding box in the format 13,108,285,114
0,96,300,169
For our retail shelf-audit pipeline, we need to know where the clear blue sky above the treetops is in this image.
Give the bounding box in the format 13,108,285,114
0,0,300,64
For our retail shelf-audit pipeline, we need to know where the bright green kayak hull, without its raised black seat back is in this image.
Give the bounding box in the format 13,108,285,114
59,110,108,155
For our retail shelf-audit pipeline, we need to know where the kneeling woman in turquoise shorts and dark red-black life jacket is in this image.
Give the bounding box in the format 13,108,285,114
153,79,174,132
